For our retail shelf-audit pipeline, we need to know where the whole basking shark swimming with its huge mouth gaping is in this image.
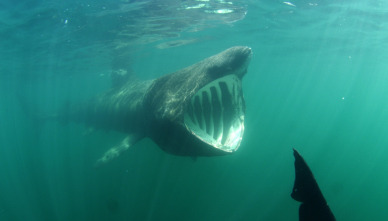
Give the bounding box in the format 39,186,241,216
61,46,252,165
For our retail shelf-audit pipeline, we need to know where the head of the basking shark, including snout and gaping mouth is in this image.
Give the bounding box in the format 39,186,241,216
145,46,252,156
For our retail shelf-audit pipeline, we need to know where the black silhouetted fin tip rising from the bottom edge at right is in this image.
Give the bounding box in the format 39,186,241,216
291,149,336,221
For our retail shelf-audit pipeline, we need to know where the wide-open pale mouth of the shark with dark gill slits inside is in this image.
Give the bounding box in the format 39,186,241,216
184,75,245,152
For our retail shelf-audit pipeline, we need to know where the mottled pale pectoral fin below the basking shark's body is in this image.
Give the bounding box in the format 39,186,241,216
95,134,143,167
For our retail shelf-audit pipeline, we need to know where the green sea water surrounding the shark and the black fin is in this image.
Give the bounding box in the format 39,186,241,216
0,0,388,221
